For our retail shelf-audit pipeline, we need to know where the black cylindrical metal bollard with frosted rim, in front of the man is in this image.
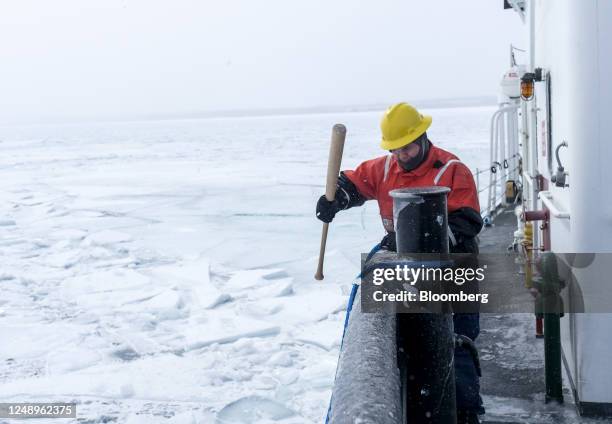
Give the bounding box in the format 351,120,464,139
389,187,457,424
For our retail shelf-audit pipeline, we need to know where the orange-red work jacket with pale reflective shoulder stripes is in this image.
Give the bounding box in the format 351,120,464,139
344,144,480,231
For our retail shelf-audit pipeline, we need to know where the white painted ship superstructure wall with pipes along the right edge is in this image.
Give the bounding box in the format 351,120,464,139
498,0,612,415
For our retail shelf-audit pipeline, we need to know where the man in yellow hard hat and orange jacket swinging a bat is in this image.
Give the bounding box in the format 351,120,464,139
317,103,484,424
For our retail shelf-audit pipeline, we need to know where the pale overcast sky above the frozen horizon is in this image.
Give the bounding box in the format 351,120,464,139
0,0,526,123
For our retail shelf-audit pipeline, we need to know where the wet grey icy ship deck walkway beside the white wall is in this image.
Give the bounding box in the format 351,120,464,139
476,209,606,424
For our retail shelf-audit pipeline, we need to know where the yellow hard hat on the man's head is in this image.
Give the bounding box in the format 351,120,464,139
380,103,431,150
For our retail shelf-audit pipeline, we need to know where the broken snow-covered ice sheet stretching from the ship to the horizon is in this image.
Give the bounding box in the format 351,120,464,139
0,107,495,423
